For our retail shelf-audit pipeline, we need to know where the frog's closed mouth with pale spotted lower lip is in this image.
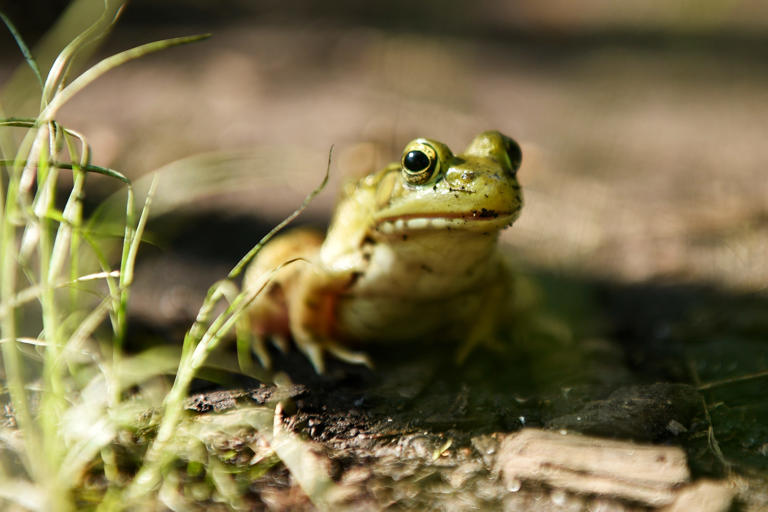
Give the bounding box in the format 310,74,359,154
376,208,518,234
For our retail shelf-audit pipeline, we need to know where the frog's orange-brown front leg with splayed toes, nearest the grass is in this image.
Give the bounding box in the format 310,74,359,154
288,265,373,373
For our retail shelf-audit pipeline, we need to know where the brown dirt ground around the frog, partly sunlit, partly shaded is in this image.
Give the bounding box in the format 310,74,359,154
0,2,768,510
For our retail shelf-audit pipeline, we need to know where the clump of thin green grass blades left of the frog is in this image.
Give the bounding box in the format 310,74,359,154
0,3,334,510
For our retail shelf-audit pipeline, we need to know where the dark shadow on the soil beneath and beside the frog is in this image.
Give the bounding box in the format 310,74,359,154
123,214,768,506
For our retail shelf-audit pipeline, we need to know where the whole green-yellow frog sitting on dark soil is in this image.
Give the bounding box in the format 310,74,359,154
245,131,523,373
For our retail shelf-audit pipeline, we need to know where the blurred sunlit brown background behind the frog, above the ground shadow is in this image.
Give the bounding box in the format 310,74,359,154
0,0,768,308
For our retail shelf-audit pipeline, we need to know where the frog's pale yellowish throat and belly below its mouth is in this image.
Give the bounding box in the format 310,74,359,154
336,232,501,342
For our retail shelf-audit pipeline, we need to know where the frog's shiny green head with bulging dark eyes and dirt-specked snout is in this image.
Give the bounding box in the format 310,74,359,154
374,131,523,234
